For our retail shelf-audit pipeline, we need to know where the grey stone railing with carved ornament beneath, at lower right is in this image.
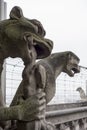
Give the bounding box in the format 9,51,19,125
46,106,87,130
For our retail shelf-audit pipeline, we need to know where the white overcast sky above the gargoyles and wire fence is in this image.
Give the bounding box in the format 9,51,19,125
5,0,87,66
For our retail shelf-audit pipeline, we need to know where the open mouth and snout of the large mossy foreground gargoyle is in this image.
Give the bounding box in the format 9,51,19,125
24,32,53,59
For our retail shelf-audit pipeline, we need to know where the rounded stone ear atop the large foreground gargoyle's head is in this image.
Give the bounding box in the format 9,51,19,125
10,6,23,19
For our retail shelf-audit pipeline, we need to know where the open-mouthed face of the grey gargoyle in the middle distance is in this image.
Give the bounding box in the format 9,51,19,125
64,51,80,77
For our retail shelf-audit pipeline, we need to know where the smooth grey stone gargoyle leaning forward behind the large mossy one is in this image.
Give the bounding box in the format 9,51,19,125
11,51,80,106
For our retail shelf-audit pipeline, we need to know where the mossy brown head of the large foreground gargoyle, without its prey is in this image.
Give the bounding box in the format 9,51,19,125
0,6,53,105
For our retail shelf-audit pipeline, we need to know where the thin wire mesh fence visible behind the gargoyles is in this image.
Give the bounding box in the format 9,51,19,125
6,58,87,105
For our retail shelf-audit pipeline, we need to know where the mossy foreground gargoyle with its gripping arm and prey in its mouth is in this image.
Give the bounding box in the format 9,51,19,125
0,6,53,128
